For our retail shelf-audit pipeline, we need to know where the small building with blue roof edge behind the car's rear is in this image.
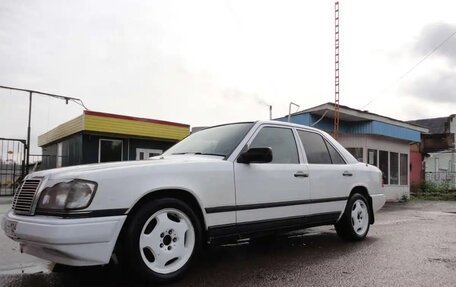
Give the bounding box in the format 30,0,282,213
278,103,428,200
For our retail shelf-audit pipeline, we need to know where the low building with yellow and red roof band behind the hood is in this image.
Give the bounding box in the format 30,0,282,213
38,111,190,169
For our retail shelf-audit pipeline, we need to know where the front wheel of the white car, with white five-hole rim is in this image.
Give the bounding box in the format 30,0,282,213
120,198,201,283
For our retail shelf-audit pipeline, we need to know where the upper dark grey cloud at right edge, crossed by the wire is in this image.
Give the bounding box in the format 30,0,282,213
413,23,456,63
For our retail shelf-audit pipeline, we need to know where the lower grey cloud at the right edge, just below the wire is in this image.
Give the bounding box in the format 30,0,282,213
405,69,456,103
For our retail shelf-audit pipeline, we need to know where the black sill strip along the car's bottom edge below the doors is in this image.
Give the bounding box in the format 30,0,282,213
208,212,341,240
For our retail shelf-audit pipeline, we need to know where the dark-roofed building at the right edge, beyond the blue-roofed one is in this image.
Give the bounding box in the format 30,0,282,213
409,115,456,189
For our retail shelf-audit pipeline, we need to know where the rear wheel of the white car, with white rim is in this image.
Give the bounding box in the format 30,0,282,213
335,193,370,241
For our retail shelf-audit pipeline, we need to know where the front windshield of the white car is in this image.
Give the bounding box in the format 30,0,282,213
165,123,253,157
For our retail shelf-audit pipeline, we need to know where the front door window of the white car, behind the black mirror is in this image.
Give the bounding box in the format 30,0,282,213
250,127,299,163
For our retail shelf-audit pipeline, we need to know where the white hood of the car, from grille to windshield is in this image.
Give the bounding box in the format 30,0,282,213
27,155,224,179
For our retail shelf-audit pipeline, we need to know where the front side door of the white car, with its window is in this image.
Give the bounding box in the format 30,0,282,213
234,125,310,225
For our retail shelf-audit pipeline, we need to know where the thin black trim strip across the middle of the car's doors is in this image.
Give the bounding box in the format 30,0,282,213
205,196,348,213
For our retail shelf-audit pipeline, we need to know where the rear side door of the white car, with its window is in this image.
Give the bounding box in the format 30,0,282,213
297,130,354,214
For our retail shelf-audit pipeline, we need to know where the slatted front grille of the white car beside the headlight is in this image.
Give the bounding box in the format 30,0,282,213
12,179,41,215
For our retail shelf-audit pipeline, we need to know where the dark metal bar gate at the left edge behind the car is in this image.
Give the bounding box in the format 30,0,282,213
0,138,26,196
